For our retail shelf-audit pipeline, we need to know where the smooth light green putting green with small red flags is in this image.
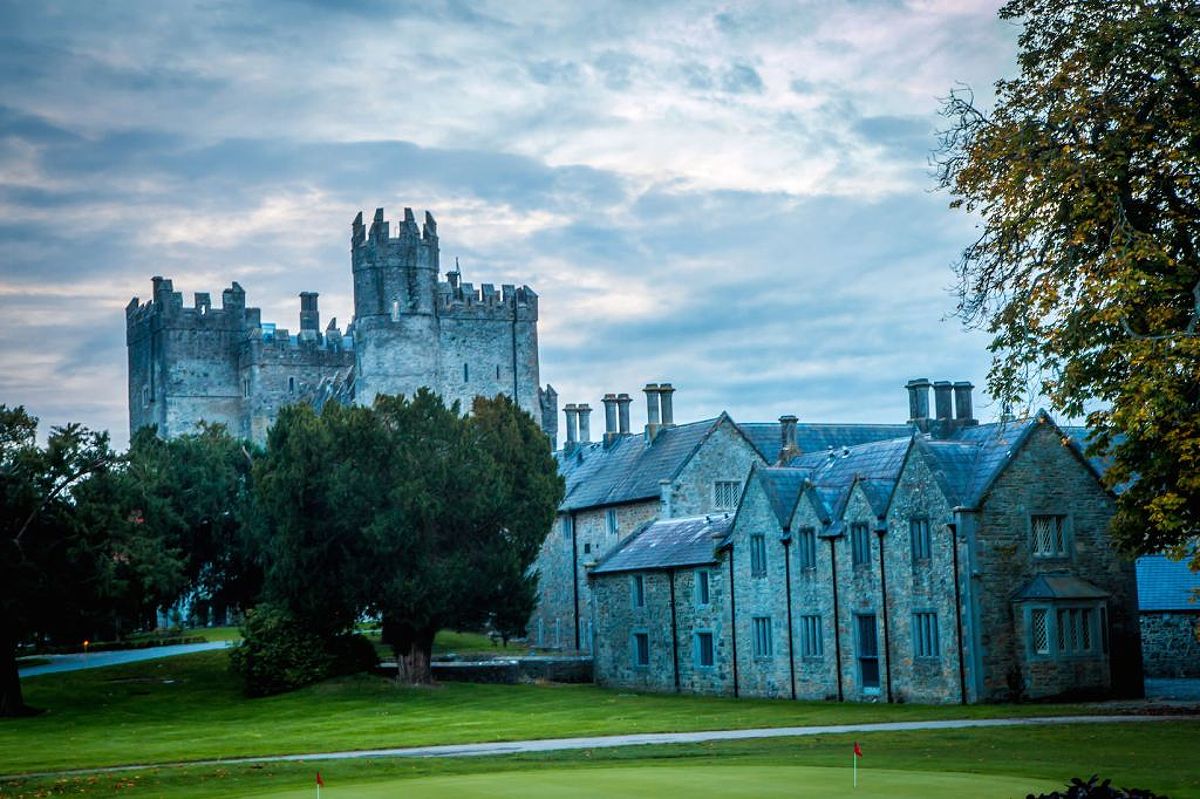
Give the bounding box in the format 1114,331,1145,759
260,762,1055,799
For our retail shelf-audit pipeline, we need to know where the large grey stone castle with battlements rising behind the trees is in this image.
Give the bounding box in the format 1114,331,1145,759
125,208,558,443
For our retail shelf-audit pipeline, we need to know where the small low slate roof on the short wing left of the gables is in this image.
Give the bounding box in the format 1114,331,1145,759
592,513,733,575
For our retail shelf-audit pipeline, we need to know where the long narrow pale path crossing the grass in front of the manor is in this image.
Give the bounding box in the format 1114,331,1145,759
7,715,1200,782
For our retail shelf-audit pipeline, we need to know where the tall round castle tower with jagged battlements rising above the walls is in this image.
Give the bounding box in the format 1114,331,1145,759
350,208,440,404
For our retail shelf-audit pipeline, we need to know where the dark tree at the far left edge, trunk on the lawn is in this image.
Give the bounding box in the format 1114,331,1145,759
0,405,179,716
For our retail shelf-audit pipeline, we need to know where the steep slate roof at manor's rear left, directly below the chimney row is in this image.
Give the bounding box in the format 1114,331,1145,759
554,414,737,511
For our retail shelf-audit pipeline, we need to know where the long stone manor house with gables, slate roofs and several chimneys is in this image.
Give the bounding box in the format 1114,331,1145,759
530,379,1142,703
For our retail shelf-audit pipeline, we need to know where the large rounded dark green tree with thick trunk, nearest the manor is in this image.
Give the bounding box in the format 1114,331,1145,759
256,390,563,681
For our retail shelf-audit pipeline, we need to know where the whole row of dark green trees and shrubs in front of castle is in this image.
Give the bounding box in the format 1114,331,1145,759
0,390,563,716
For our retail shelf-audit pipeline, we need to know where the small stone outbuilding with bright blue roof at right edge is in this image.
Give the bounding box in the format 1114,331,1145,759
1138,555,1200,678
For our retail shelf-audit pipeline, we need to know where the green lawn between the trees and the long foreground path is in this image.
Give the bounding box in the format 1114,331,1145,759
0,651,1176,774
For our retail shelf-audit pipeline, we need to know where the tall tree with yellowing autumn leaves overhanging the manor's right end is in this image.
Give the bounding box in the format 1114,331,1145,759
935,0,1200,569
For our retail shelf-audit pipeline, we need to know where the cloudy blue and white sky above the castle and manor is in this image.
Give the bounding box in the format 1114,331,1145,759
0,0,1018,445
